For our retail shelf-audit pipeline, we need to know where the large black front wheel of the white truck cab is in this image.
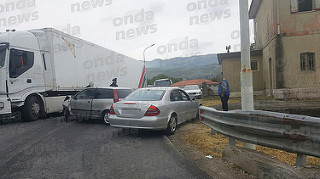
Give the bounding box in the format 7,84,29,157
23,96,41,121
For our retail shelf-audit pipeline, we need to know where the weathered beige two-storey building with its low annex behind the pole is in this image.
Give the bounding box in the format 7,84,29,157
218,0,320,99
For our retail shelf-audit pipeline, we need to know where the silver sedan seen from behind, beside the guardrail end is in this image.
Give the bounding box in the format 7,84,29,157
109,87,199,135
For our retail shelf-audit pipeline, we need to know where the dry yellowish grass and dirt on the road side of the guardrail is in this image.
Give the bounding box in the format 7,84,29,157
169,121,320,179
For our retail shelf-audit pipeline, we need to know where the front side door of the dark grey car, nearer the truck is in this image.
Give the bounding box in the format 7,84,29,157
71,88,95,118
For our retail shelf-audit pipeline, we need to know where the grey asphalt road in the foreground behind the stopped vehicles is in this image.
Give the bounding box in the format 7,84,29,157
0,117,210,179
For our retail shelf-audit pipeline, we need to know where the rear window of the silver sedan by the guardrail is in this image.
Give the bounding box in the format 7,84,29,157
125,89,166,101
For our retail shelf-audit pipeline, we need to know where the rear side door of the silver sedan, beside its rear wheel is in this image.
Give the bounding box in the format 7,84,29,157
170,89,187,124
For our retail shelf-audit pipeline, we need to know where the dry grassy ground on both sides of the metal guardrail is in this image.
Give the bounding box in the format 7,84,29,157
169,97,320,178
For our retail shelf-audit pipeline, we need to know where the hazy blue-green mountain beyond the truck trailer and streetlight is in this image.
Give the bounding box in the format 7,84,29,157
146,54,221,79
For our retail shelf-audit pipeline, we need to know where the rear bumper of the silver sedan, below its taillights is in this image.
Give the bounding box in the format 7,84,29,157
109,115,168,130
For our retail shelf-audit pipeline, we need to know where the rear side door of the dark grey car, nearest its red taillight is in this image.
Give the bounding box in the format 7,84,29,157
91,88,113,118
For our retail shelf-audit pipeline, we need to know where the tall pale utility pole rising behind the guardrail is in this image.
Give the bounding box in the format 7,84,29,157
239,0,256,150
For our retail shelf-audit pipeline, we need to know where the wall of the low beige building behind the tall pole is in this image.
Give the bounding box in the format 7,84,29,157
222,56,264,94
